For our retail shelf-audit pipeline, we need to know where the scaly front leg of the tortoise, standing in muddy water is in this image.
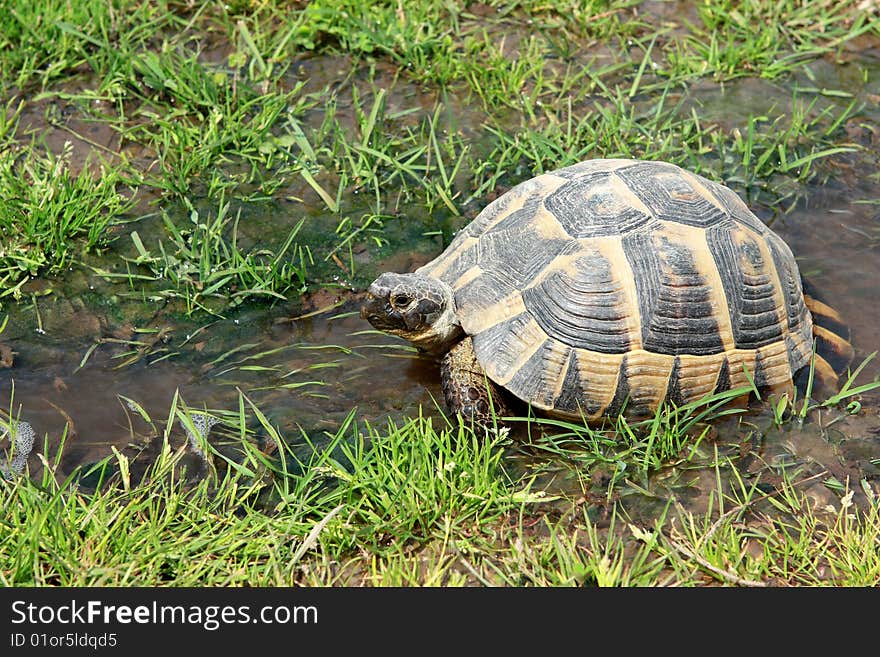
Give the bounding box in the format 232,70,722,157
440,337,510,427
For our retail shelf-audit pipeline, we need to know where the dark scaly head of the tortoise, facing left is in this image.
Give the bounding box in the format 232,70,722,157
361,272,462,355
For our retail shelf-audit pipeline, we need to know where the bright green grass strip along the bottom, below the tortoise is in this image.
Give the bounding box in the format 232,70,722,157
0,384,880,586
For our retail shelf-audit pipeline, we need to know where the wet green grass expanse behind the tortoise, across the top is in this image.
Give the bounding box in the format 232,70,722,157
0,0,880,308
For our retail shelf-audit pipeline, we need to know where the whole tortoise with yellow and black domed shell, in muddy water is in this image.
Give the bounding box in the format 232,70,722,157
361,159,852,422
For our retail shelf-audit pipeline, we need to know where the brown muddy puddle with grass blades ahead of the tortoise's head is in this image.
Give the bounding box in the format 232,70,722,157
0,300,441,475
